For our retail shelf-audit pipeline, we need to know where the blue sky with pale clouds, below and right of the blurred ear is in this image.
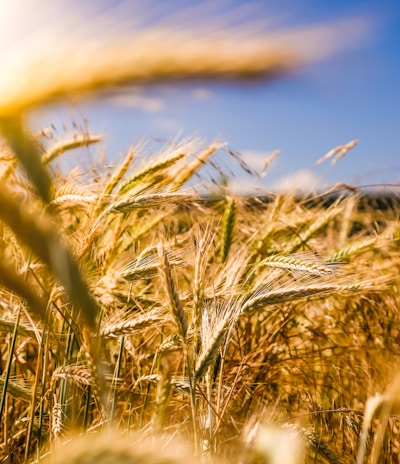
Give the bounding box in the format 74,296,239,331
28,0,400,192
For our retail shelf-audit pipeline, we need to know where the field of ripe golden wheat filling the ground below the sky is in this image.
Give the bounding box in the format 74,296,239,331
0,4,400,464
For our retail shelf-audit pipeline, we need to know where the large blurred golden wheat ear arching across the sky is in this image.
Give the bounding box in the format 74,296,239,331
0,10,366,117
